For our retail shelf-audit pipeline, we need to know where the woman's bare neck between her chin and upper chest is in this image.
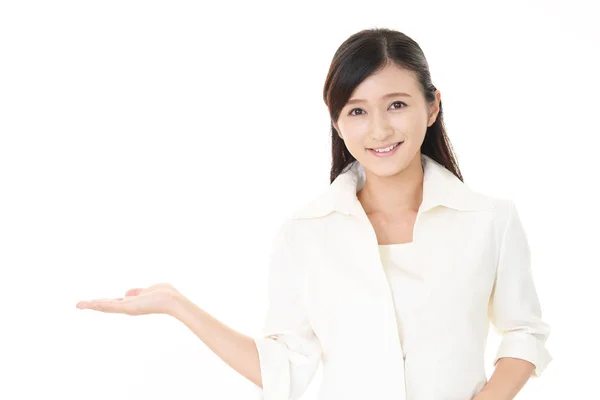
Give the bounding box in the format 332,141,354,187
357,154,423,215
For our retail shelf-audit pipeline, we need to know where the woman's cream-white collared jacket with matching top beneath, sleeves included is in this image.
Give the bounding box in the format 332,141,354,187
254,155,552,400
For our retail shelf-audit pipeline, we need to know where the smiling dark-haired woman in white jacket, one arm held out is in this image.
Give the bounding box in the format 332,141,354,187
78,29,551,400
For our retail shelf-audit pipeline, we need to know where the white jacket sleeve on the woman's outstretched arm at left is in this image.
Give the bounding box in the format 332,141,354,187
254,220,321,400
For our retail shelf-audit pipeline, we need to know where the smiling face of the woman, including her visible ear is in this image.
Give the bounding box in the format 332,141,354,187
334,64,440,176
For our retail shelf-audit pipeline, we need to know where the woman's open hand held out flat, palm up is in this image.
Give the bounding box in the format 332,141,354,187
77,283,183,315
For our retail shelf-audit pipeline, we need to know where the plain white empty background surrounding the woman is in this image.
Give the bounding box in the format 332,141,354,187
0,1,600,400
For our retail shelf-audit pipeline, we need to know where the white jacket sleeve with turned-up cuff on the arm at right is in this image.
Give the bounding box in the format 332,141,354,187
490,200,552,377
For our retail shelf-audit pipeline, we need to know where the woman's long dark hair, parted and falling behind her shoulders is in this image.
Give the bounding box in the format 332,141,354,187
323,28,463,183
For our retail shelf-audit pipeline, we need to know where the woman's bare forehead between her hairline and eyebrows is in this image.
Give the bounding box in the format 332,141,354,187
351,64,419,100
